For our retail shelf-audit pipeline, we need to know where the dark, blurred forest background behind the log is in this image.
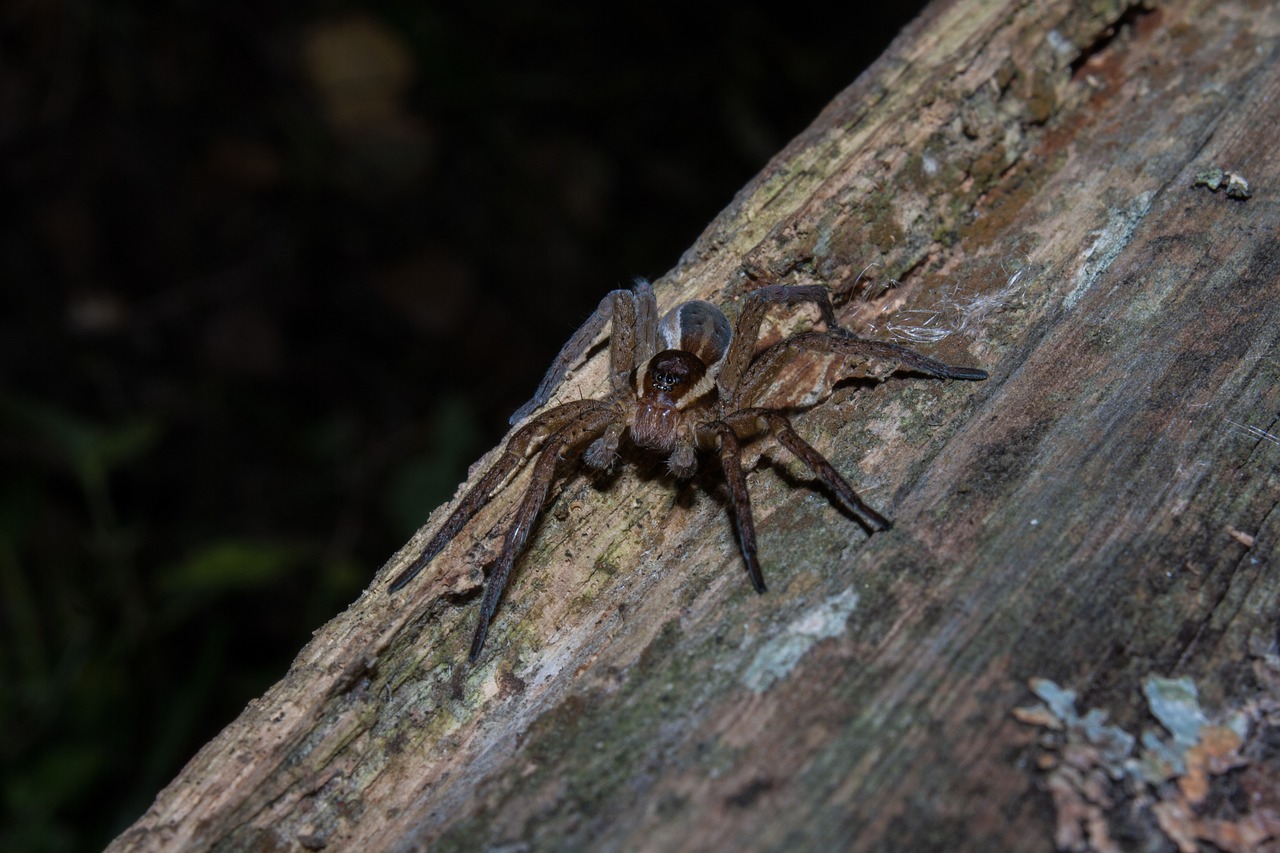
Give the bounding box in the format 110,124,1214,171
0,0,923,850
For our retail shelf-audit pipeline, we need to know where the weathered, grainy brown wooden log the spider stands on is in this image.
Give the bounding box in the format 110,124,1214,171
111,0,1280,850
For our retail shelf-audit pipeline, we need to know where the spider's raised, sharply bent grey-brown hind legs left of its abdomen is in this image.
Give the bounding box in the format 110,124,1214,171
507,278,658,424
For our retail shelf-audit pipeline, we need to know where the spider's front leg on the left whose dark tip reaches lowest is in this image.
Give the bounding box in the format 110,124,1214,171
468,401,617,663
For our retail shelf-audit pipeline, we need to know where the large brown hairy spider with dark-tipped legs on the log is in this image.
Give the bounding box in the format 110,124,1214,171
389,279,987,662
